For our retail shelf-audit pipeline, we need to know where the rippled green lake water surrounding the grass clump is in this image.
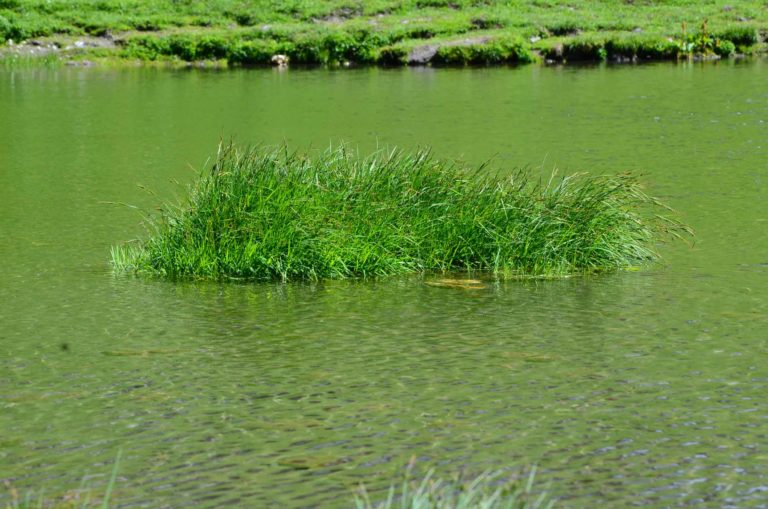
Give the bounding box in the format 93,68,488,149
0,61,768,507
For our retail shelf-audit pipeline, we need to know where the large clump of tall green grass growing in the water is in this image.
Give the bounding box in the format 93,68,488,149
112,144,687,280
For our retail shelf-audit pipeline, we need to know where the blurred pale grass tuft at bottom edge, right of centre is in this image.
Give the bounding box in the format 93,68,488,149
355,466,555,509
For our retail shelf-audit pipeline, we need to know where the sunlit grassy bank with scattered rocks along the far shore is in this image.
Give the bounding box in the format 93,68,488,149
0,0,768,65
